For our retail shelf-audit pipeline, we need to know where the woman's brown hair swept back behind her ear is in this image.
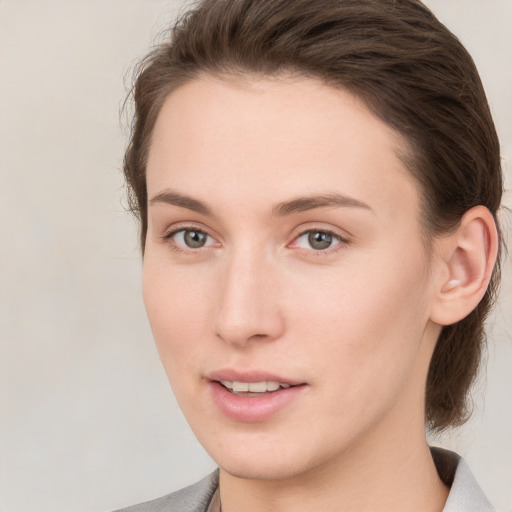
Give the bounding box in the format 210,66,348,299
124,0,503,430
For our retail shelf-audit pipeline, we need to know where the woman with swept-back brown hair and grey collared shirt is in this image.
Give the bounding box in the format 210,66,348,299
115,0,502,512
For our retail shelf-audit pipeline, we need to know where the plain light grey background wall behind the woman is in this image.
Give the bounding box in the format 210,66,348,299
0,0,512,512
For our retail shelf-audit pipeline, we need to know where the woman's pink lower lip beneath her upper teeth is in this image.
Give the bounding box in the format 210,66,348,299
209,381,307,423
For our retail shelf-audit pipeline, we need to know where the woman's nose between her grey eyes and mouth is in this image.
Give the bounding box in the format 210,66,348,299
211,251,285,348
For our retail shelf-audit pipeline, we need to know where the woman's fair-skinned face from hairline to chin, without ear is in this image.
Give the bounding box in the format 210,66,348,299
144,77,438,479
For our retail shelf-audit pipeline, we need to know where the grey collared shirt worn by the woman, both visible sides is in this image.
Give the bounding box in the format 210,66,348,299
116,448,496,512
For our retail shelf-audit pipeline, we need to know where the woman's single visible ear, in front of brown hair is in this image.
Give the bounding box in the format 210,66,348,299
430,206,498,325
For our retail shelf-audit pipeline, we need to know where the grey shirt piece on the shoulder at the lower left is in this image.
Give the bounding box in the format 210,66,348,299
115,470,219,512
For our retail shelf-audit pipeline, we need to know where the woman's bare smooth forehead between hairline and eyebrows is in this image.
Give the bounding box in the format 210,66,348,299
147,76,418,223
